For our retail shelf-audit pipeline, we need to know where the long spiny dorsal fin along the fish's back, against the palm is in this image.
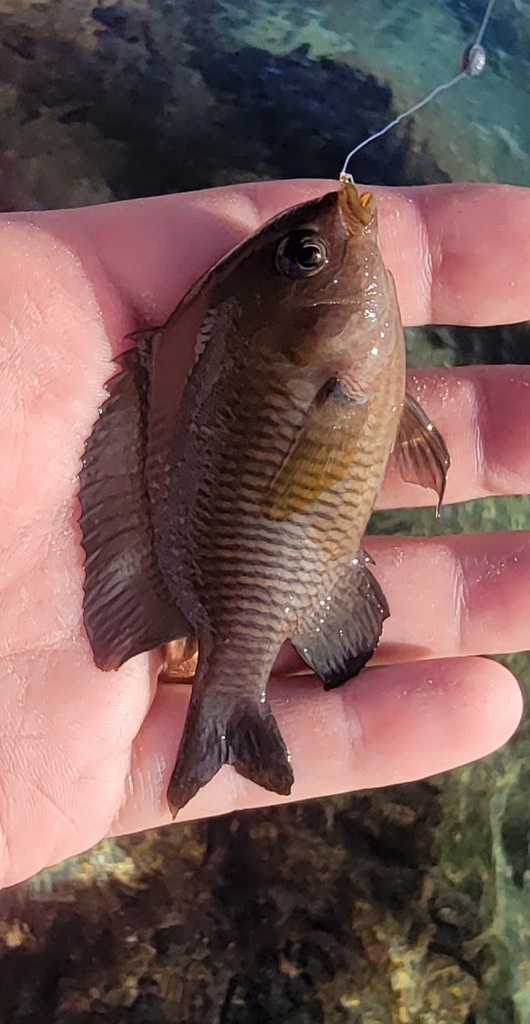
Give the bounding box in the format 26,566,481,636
79,349,191,669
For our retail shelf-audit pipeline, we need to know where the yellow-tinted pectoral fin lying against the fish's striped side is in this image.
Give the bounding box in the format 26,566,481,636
265,378,367,520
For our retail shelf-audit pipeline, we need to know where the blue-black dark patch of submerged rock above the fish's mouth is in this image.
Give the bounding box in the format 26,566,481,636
190,46,449,184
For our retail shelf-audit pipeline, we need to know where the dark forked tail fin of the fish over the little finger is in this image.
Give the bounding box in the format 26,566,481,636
168,693,294,817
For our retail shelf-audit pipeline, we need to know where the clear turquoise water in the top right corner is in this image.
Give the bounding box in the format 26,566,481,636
213,0,530,184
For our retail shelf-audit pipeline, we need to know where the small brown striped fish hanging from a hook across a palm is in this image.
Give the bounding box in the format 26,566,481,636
80,181,449,816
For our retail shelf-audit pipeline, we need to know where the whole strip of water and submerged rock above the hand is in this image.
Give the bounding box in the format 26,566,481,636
0,0,530,210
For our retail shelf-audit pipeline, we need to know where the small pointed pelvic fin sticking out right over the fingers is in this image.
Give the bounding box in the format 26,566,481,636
394,394,450,515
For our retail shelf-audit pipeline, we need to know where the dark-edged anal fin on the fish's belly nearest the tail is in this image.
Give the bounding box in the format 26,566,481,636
292,552,389,690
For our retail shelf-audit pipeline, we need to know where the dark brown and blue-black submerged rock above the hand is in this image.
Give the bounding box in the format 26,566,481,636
0,0,447,210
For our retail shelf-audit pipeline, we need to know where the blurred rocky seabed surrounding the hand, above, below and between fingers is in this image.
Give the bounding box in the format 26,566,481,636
0,0,530,1024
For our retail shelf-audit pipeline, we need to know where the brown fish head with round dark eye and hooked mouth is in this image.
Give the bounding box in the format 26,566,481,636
211,183,395,365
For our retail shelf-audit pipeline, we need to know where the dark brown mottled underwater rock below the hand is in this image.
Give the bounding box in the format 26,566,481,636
0,782,477,1024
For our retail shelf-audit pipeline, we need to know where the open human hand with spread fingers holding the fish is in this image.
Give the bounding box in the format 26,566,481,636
0,181,530,885
